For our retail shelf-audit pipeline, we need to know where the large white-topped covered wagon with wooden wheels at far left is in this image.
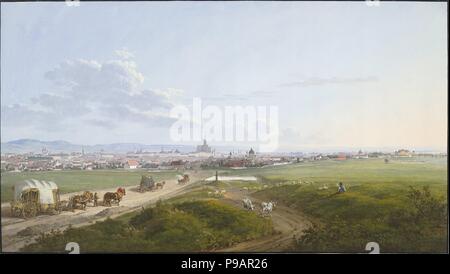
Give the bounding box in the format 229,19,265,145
11,179,60,218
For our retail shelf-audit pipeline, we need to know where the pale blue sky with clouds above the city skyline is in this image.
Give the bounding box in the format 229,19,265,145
1,2,448,150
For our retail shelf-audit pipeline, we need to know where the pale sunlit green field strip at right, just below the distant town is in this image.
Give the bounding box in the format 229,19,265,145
231,157,447,191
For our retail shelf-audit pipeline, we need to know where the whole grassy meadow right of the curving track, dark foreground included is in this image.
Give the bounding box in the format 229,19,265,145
242,158,448,252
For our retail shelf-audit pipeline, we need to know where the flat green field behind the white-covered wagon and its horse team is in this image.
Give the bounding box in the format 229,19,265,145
1,170,179,203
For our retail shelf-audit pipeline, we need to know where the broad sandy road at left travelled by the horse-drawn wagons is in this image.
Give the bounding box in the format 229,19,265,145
2,174,207,252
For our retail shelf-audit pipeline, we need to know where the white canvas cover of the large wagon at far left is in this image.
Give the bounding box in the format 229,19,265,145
14,179,58,205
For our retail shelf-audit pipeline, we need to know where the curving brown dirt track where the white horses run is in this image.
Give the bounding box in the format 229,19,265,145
217,190,311,252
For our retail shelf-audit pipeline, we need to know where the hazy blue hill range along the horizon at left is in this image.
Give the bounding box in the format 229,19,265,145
1,139,195,153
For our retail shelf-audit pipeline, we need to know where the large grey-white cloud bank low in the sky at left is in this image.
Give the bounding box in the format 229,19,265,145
2,50,183,134
